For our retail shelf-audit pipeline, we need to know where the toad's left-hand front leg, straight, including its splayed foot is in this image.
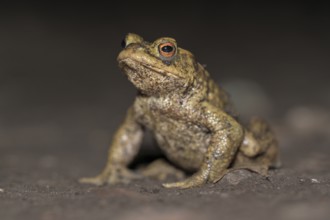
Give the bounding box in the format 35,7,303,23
79,108,143,185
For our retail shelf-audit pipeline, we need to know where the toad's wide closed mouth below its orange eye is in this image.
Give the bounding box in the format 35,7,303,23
119,58,180,78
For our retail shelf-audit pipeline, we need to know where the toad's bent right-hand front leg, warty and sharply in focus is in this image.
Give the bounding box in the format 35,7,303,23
163,103,244,188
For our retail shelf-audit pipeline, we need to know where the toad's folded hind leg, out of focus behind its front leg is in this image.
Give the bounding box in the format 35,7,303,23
232,118,279,176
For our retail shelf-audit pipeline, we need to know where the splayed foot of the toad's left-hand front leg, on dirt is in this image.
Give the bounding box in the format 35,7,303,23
79,167,141,186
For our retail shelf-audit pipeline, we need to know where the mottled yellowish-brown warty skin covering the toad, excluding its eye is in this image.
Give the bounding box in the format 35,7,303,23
81,34,277,188
